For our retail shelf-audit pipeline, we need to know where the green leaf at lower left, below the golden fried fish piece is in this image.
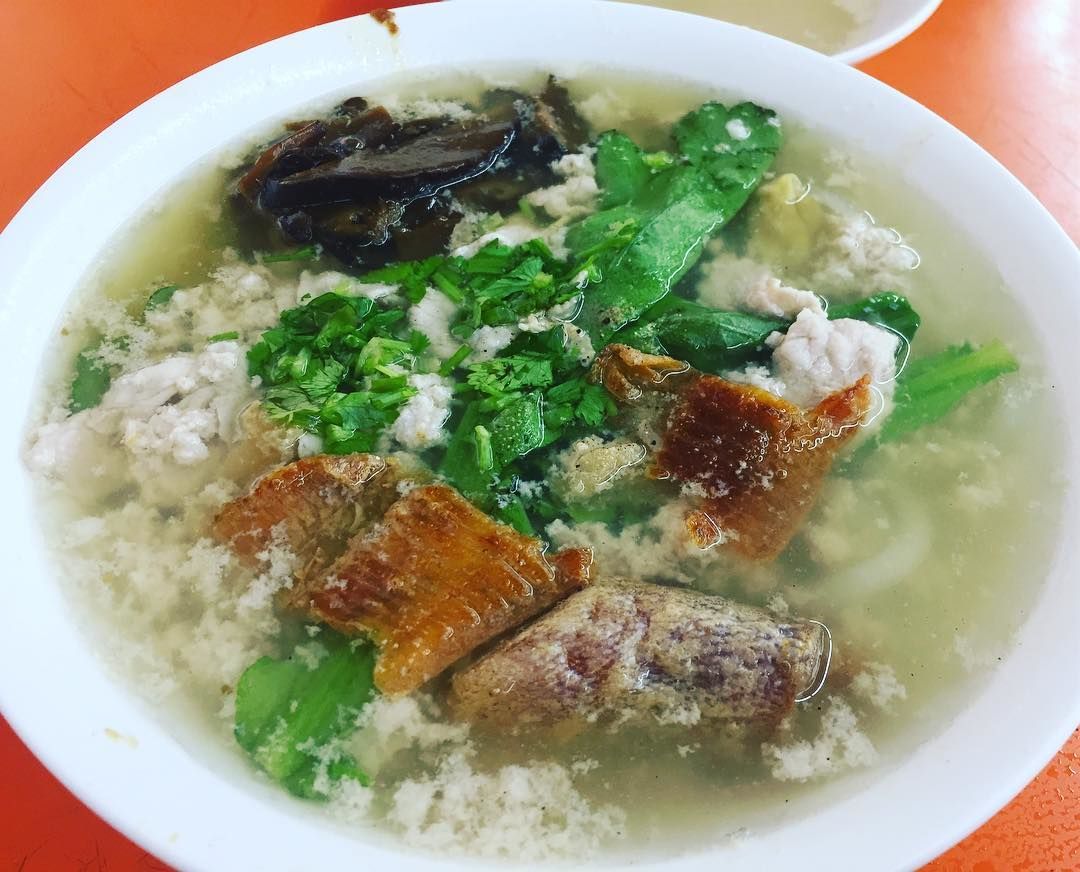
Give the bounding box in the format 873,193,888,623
234,631,375,799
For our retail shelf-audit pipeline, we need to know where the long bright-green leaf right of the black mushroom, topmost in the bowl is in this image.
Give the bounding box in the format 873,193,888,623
567,103,781,347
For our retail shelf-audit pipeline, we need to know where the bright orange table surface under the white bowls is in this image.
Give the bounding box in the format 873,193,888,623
0,0,1080,872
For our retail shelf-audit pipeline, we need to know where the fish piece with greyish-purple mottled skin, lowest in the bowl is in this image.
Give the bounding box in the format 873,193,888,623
450,580,829,730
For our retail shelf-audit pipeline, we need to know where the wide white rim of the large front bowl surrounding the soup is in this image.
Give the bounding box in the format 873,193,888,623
0,0,1080,872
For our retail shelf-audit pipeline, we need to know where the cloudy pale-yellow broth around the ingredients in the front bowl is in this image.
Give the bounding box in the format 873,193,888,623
25,69,1059,857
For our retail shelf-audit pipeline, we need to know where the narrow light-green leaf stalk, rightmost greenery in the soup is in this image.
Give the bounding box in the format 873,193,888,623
878,340,1020,442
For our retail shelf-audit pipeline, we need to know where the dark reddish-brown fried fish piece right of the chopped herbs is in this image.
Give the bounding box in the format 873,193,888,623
592,345,870,561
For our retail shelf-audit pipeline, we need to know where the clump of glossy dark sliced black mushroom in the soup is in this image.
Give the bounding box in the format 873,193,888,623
237,78,588,269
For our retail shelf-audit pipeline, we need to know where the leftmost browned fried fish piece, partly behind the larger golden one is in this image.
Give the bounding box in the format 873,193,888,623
213,454,402,576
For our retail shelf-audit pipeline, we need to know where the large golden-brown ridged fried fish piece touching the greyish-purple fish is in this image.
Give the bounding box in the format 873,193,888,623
305,484,592,694
